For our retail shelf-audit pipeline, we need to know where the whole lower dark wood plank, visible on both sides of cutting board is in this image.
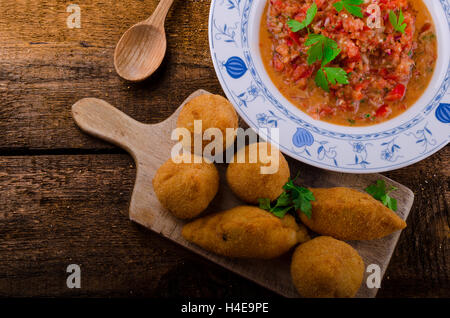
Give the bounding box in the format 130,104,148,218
0,147,450,297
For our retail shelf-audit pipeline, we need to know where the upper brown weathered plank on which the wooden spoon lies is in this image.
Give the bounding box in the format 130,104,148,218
0,0,221,149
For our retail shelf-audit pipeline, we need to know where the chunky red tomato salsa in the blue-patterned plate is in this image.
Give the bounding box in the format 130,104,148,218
260,0,437,126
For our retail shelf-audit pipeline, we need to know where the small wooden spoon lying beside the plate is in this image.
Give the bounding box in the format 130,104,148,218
114,0,174,82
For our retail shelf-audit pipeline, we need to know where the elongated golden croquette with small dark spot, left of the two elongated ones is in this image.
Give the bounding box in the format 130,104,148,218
182,206,309,259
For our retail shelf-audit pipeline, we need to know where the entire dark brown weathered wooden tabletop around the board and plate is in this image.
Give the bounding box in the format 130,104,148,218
0,0,450,297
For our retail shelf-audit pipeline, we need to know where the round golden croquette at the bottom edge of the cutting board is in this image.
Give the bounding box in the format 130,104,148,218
291,236,364,298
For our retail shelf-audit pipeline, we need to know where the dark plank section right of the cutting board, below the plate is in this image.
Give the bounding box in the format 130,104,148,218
379,152,450,297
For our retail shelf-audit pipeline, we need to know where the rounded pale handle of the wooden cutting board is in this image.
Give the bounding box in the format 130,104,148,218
72,98,146,155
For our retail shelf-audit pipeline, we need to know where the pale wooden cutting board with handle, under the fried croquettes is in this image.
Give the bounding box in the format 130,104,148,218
72,90,414,297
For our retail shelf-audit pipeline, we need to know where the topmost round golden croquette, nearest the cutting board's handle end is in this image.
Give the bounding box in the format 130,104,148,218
177,94,238,155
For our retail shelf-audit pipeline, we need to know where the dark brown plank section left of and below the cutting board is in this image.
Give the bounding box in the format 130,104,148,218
0,155,272,297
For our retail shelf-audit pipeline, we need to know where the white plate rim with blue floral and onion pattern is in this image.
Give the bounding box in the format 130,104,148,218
209,0,450,173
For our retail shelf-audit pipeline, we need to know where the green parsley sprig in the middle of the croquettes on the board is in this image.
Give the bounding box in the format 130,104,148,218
259,178,316,219
